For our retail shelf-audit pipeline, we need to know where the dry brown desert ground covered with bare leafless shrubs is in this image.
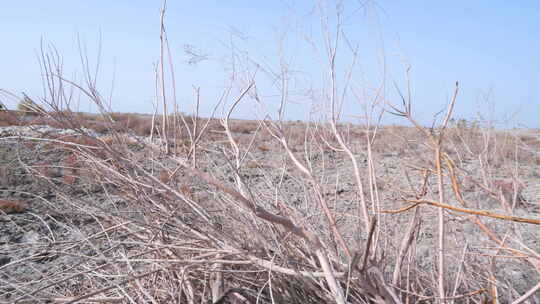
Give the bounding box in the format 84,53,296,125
0,111,540,303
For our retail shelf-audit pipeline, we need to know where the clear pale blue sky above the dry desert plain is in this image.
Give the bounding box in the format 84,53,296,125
0,0,540,128
